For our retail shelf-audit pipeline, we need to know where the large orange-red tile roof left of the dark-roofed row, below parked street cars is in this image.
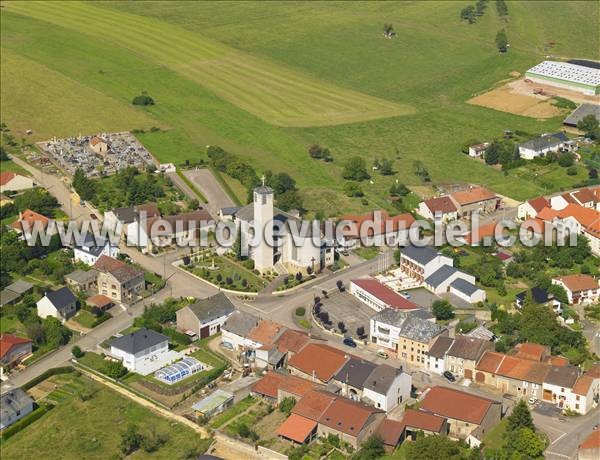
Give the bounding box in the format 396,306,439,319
288,343,348,382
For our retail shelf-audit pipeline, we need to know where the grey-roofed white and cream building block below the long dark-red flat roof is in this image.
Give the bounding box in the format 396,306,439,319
369,308,448,367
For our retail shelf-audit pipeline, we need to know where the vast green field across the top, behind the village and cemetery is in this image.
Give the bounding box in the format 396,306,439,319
1,2,600,214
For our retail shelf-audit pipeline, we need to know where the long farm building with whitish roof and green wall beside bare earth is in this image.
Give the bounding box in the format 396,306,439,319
525,61,600,94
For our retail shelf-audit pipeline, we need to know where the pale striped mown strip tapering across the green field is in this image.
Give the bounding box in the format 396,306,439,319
8,2,414,127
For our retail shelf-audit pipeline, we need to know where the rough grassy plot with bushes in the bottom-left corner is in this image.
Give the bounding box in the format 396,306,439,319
2,375,210,459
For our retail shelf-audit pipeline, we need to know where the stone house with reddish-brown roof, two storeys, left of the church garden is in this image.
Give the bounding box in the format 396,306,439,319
93,255,146,303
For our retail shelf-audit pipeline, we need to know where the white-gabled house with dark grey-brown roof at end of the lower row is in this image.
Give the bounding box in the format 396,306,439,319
363,364,412,412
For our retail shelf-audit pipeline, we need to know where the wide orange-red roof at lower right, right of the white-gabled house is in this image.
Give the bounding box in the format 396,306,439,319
421,386,499,425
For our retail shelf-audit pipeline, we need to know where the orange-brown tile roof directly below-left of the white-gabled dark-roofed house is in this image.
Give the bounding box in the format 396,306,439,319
319,397,383,436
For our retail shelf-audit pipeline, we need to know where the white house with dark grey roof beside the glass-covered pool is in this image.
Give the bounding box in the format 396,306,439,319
109,328,179,375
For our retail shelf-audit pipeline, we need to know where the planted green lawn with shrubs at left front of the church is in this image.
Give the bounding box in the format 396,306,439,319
186,254,266,292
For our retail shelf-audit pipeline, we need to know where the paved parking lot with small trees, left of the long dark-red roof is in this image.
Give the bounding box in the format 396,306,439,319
321,292,376,339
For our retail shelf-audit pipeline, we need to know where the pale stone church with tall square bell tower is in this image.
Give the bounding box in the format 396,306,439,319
234,183,334,274
